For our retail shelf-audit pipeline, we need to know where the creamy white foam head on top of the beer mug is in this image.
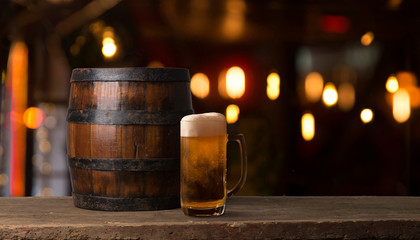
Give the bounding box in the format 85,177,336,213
181,112,226,137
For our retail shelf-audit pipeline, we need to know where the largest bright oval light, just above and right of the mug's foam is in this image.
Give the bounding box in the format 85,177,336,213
226,66,245,98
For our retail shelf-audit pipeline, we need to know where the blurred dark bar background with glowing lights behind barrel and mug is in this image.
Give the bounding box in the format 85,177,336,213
0,0,420,196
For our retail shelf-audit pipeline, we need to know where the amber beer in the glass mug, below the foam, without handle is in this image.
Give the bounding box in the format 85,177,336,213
181,135,227,215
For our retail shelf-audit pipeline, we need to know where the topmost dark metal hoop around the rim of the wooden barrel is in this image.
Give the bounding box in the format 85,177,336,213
70,67,190,82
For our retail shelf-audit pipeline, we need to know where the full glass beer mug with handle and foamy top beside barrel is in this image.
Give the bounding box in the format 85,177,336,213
180,113,247,216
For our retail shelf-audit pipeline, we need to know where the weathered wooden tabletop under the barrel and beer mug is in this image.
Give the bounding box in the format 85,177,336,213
0,196,420,239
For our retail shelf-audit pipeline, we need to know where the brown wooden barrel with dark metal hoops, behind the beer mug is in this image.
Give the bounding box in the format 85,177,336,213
67,68,193,211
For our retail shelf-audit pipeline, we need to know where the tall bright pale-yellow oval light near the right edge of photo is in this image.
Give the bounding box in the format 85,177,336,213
392,89,411,123
